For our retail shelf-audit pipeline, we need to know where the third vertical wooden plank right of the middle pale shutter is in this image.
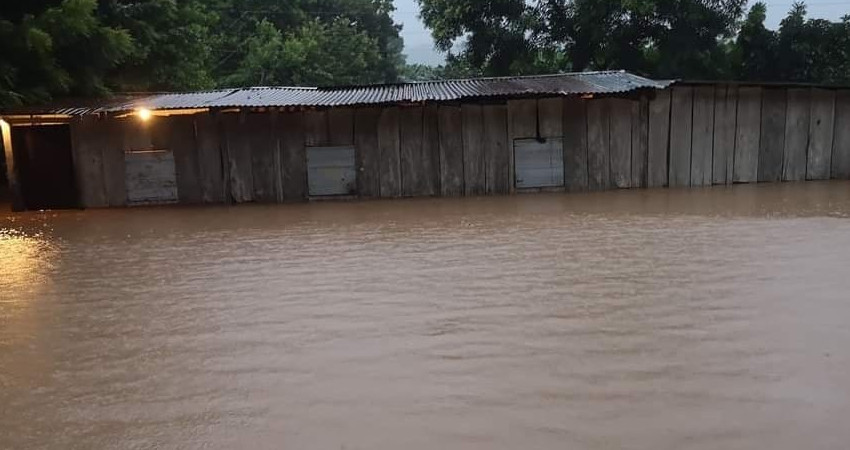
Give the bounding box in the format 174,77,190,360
399,106,425,197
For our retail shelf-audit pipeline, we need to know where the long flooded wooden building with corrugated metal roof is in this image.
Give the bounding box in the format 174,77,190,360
0,71,850,209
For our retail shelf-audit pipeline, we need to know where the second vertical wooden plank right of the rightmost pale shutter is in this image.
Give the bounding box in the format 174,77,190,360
587,99,611,191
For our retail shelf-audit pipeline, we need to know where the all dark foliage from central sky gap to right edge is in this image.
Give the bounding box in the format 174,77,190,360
418,0,850,82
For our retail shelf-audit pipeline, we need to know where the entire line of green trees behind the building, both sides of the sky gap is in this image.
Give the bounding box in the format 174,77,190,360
0,0,850,106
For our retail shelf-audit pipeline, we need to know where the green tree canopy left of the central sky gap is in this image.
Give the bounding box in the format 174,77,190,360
0,0,404,106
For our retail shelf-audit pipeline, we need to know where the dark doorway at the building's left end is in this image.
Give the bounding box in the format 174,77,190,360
12,125,78,209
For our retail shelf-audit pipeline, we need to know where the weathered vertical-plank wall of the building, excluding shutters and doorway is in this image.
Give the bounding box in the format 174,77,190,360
56,84,850,207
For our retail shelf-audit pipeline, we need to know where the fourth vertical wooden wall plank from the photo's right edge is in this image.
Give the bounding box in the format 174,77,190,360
758,89,788,182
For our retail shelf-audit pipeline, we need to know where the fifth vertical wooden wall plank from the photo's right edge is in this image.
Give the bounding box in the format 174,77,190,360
732,87,761,183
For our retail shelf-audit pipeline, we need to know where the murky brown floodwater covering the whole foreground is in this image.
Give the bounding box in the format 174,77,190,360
0,183,850,450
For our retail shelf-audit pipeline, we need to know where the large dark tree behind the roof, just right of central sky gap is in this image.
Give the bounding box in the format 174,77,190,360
418,0,746,78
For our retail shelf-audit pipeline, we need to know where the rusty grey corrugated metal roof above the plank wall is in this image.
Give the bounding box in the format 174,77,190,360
1,71,671,115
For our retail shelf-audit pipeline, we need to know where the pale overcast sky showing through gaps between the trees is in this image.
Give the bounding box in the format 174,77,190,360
394,0,850,65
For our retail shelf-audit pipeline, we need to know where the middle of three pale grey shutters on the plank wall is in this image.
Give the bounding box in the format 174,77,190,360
307,147,357,197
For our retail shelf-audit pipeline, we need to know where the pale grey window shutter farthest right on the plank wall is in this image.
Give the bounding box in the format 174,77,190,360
514,138,564,189
